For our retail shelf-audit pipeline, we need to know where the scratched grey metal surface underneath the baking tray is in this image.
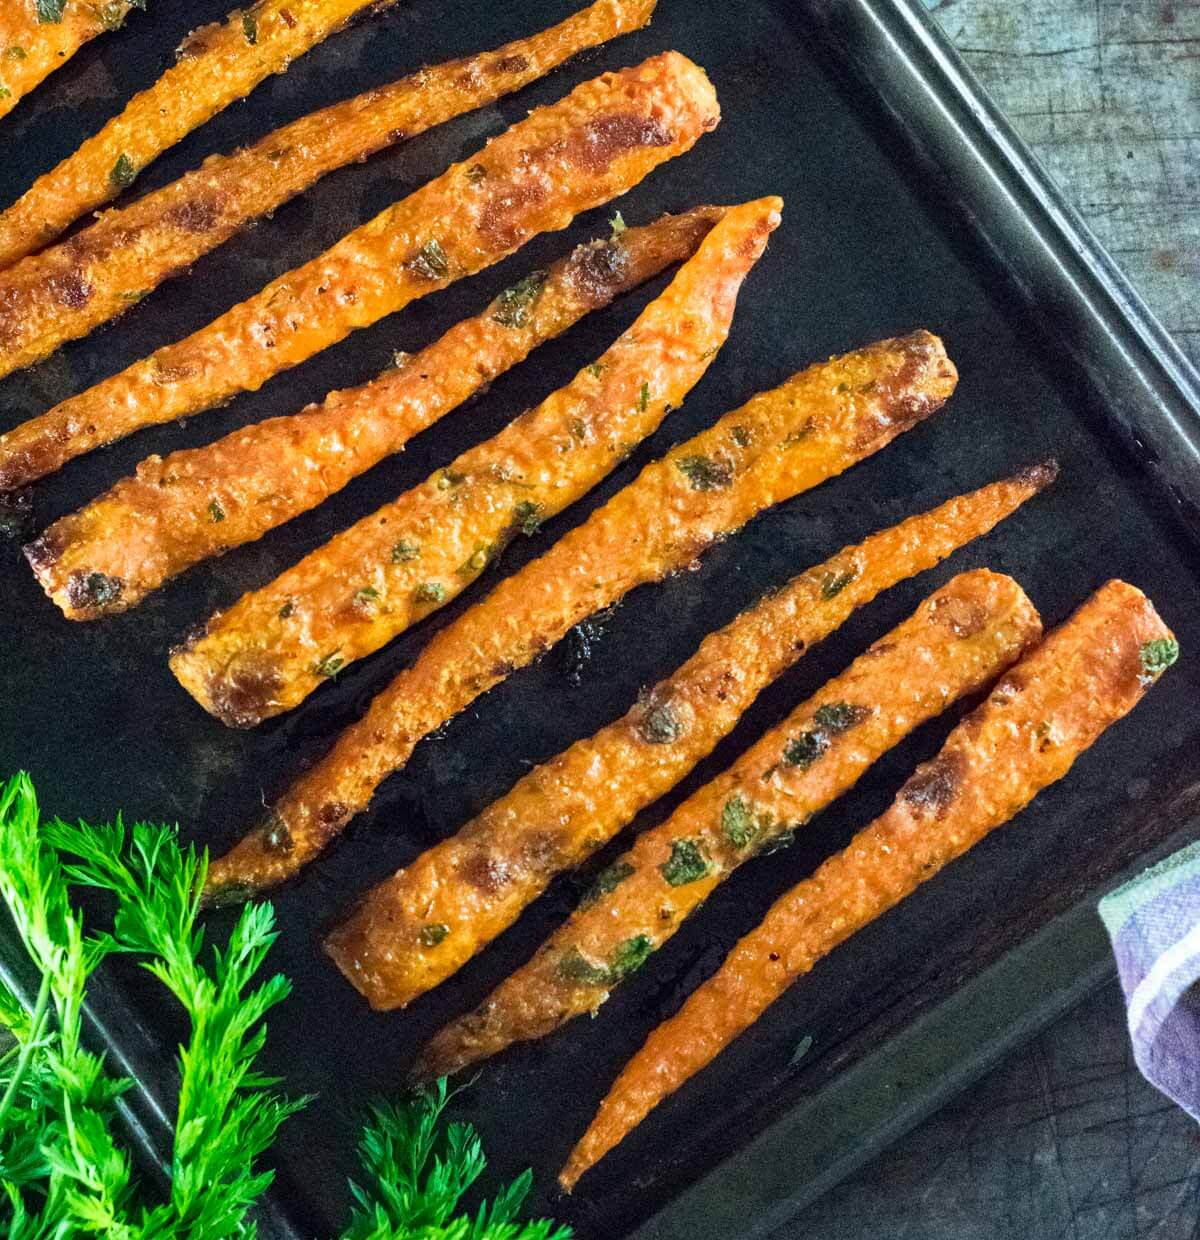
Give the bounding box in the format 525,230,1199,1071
779,0,1200,1240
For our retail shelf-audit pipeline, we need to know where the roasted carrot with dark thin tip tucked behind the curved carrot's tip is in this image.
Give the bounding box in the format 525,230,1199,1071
26,207,725,620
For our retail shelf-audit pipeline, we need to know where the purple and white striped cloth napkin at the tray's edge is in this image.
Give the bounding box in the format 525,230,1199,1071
1100,842,1200,1120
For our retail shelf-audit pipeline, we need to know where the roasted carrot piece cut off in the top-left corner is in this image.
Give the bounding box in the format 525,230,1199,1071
0,0,145,117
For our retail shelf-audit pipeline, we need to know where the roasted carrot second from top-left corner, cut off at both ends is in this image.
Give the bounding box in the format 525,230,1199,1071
0,0,393,267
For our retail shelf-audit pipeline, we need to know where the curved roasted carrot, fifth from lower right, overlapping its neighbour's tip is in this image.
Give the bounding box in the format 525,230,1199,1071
171,198,782,724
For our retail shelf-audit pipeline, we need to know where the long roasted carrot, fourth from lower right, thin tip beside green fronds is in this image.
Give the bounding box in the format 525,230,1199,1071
208,332,957,898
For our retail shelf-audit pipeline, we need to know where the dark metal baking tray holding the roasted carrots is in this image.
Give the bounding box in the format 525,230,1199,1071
0,0,1200,1240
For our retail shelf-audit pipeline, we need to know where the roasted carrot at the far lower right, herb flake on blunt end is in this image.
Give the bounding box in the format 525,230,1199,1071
559,582,1179,1190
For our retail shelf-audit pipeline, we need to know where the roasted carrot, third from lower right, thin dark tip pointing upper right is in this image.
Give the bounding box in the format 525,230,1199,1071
326,463,1056,1009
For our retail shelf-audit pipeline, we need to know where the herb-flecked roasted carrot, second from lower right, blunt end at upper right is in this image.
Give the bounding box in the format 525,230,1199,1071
417,569,1041,1078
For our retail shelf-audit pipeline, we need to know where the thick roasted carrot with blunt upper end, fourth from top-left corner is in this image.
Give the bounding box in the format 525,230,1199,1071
0,53,719,491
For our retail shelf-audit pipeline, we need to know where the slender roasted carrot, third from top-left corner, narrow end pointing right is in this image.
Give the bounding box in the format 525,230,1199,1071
0,0,655,376
